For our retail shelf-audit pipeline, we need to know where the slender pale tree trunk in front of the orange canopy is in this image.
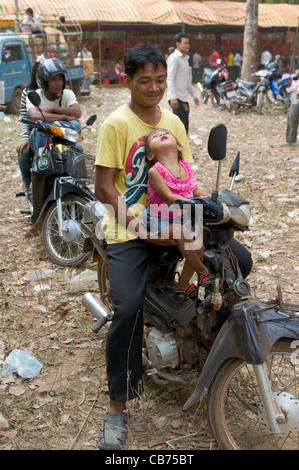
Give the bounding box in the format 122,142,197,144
241,0,259,81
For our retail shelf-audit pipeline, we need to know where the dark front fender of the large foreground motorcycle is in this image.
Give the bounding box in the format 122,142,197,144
183,299,299,409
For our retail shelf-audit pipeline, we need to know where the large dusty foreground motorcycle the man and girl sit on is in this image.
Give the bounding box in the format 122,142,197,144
82,124,299,450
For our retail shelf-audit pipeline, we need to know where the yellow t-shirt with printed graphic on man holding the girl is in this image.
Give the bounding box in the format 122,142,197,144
95,104,192,243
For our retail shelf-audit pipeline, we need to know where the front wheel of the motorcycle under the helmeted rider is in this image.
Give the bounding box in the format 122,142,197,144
42,195,89,266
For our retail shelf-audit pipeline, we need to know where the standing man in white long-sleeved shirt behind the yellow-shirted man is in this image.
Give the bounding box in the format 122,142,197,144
167,33,199,134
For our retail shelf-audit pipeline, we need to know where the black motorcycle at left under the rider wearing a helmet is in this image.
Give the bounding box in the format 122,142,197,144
16,91,96,266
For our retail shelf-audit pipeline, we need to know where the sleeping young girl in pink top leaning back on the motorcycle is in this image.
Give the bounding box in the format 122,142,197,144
145,129,209,297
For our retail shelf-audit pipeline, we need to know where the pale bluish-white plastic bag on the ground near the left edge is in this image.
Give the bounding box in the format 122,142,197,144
1,349,43,379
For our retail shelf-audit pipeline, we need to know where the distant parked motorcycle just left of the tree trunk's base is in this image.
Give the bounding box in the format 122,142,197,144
197,59,236,112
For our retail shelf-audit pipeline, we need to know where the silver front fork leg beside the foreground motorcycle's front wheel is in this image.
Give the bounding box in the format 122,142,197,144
253,363,285,434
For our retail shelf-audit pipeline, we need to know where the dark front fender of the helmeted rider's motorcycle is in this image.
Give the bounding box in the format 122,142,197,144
28,181,97,236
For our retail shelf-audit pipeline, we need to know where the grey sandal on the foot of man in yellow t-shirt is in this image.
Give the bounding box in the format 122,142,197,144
99,414,128,450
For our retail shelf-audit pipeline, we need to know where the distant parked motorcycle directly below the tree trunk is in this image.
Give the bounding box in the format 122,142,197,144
235,69,269,114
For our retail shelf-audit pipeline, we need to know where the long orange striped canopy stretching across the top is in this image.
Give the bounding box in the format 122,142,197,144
0,0,299,28
